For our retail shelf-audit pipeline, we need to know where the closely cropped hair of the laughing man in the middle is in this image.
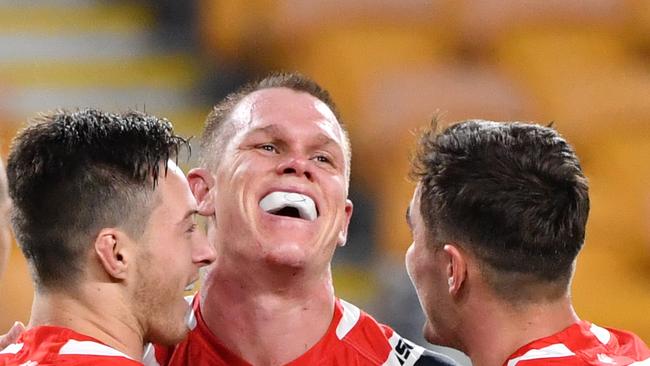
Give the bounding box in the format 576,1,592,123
201,72,350,174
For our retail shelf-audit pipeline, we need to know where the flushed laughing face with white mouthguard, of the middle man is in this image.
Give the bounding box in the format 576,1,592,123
211,88,352,270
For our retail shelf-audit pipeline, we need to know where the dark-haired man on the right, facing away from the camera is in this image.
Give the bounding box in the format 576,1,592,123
406,121,650,366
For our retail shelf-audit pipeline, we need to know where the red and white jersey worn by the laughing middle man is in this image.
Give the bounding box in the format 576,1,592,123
156,296,455,366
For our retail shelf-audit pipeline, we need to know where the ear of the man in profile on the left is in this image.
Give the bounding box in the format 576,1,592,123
95,228,131,280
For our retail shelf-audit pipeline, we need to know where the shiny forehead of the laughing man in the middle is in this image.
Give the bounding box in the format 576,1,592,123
231,88,343,142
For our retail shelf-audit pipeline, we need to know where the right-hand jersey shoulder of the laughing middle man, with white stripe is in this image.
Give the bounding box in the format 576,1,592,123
336,300,456,366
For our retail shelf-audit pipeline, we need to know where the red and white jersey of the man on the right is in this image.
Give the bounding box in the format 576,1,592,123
503,321,650,366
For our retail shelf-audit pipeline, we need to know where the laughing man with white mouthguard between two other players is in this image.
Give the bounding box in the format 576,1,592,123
158,74,452,366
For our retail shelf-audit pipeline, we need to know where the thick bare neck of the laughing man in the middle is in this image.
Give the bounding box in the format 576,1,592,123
201,256,334,365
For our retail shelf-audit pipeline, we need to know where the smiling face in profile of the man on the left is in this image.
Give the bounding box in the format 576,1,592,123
133,161,215,345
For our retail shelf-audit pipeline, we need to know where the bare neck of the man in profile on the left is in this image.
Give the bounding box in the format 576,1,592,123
29,284,144,360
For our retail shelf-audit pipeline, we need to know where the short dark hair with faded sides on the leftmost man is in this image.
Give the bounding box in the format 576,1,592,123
7,109,187,290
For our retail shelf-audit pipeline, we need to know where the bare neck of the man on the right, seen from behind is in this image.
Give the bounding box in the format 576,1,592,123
461,295,579,366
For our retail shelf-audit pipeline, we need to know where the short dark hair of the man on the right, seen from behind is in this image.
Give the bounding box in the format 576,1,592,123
412,120,589,300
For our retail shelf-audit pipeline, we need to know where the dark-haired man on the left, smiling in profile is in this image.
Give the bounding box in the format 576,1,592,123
0,109,214,365
